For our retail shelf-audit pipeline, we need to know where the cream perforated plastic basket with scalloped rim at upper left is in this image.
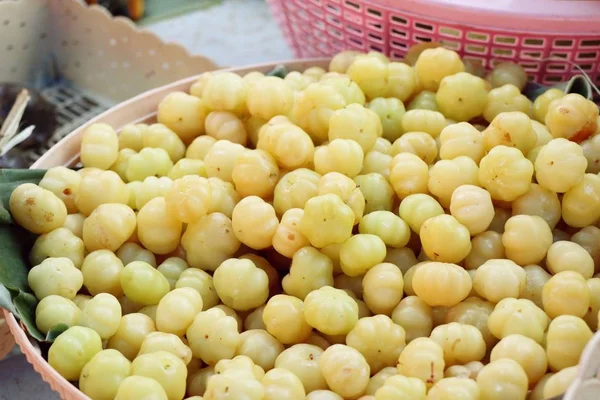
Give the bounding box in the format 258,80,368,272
0,0,216,162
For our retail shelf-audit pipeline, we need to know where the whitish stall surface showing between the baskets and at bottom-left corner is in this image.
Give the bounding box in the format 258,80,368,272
0,0,293,400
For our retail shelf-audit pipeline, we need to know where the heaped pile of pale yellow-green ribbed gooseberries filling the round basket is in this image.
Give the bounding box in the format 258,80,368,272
5,48,600,400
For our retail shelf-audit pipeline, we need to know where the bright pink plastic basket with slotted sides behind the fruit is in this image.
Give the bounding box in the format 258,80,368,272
267,0,600,85
